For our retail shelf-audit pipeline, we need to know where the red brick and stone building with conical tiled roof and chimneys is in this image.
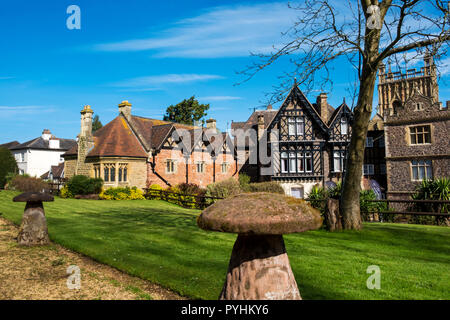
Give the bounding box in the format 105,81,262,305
64,101,238,189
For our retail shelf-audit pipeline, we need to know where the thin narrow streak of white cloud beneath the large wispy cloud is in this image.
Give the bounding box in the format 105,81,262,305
112,74,223,87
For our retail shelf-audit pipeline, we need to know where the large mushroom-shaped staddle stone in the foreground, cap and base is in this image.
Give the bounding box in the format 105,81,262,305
197,192,322,300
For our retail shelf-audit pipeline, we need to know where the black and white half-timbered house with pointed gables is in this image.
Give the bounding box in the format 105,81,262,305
232,85,353,198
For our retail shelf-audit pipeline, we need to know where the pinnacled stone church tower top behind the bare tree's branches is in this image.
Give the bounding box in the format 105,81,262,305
378,53,439,116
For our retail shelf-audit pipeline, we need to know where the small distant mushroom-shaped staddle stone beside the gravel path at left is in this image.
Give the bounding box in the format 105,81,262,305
13,192,54,246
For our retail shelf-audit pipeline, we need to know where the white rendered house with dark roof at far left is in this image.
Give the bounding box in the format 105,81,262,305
10,129,76,177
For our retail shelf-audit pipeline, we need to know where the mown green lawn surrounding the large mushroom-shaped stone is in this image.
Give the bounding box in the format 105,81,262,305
0,191,450,299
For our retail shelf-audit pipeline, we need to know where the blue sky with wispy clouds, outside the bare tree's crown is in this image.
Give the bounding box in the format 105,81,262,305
0,0,450,143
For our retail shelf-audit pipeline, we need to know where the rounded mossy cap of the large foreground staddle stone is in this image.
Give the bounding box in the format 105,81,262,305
197,192,323,235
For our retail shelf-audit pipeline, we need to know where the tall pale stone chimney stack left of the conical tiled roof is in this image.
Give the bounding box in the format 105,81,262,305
75,105,94,176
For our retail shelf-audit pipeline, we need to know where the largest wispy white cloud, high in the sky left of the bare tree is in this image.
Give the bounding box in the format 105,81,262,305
94,2,296,58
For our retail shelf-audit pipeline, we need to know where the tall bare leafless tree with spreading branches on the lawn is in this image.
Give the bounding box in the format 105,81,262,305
240,0,450,229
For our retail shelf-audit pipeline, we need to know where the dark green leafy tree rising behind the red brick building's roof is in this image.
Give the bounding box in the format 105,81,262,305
164,96,209,125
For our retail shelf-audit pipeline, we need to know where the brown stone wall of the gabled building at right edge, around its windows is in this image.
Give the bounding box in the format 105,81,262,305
384,93,450,198
